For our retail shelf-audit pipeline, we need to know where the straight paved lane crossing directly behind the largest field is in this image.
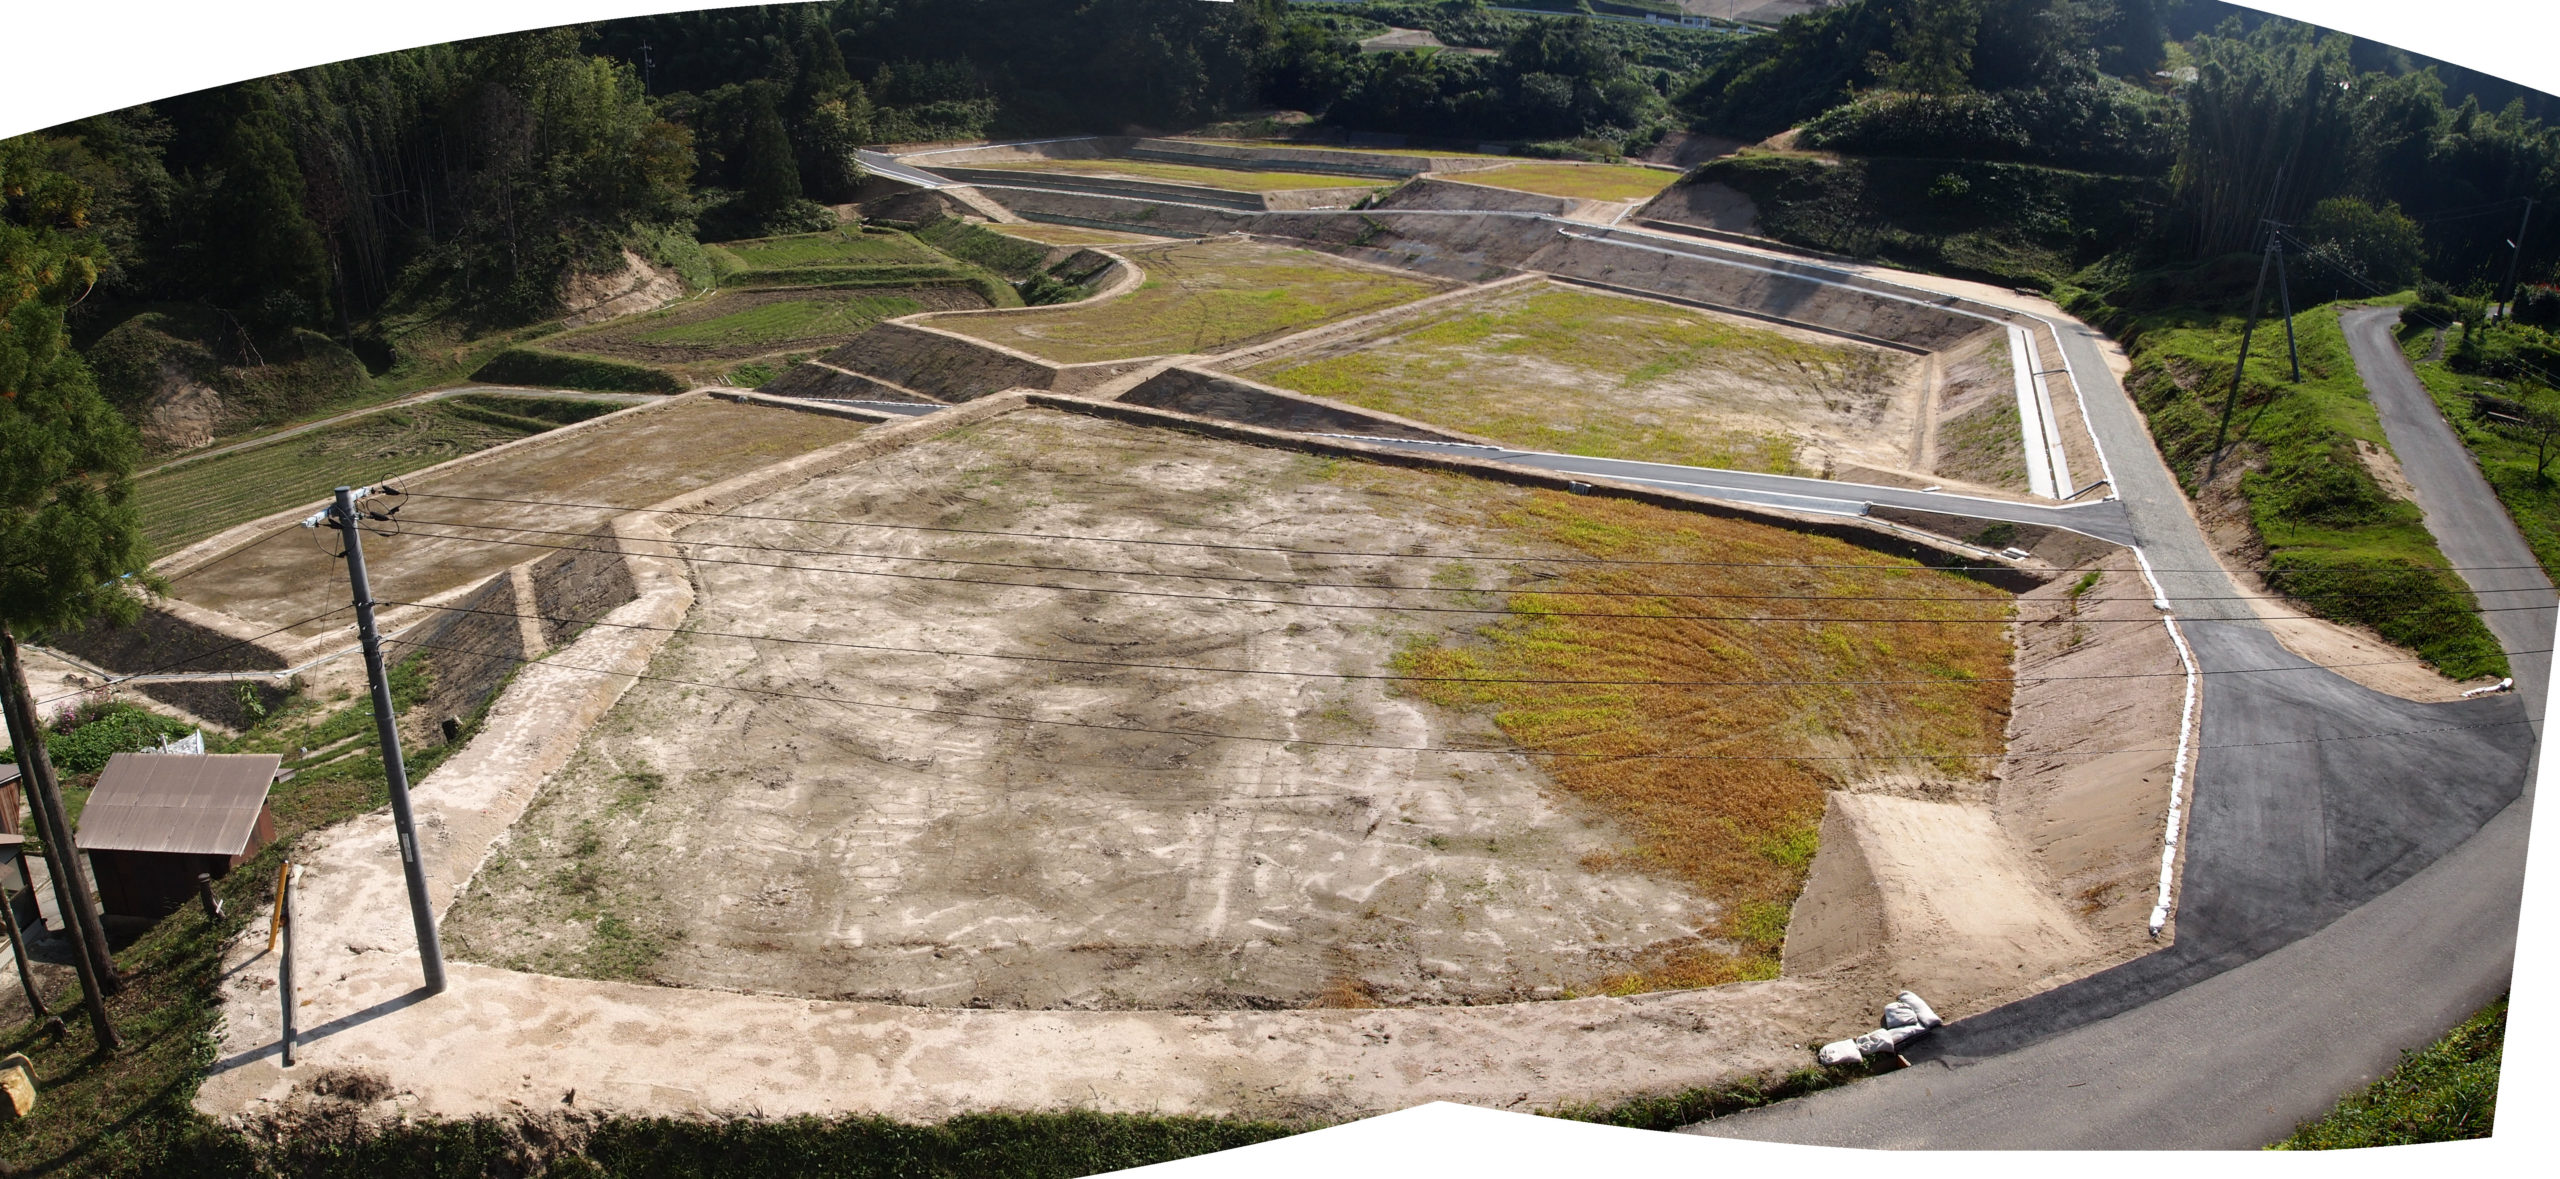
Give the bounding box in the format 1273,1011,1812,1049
1334,435,2132,545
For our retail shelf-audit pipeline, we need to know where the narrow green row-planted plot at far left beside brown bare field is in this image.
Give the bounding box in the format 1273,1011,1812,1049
133,396,622,555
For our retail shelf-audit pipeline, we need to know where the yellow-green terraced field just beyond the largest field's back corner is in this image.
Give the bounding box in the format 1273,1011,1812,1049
932,238,1436,363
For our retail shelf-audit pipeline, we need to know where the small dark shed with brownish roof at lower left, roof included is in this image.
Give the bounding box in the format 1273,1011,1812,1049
74,752,284,918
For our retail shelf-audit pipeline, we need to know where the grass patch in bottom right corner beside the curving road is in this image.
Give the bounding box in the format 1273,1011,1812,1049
2268,997,2506,1151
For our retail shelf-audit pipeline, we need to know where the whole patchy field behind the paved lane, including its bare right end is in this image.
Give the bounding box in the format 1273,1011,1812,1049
1244,284,1935,476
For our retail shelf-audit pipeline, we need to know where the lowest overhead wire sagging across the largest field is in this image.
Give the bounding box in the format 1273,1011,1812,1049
384,642,2532,762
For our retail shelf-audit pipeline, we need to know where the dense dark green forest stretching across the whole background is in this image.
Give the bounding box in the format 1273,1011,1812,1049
5,0,2560,450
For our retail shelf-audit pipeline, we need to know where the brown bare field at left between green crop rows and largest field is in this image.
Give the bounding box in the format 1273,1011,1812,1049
172,396,863,637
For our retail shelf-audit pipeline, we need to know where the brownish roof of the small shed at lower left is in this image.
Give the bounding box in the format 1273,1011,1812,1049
74,754,284,857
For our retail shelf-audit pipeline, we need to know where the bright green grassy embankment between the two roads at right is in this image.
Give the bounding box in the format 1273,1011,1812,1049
2125,304,2506,678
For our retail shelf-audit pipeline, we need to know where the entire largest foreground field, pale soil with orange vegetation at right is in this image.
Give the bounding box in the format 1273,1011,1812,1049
445,409,2010,1008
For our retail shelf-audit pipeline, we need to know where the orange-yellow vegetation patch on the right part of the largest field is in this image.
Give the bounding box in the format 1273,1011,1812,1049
1395,491,2010,995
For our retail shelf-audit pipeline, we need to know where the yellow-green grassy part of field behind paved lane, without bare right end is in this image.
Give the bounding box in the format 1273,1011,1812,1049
1249,286,1866,473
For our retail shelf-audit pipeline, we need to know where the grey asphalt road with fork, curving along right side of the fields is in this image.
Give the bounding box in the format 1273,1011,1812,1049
1692,308,2552,1148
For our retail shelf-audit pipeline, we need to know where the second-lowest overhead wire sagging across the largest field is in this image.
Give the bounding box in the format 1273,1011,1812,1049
384,601,2537,688
